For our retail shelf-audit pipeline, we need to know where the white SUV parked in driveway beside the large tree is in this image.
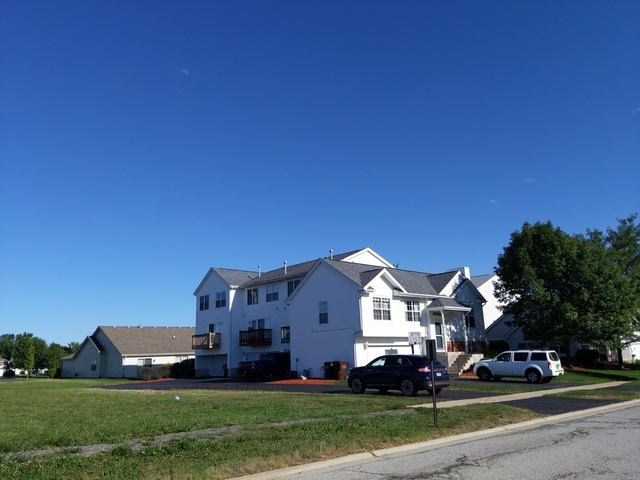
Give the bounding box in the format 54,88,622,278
473,350,564,383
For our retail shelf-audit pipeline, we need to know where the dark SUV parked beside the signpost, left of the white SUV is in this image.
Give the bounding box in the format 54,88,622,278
347,355,449,396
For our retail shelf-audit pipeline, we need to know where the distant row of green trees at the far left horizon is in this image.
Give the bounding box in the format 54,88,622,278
0,332,80,376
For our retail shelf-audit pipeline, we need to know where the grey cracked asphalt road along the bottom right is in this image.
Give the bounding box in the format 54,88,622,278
250,402,640,480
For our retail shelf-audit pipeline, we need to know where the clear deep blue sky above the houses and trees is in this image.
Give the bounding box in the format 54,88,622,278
0,0,640,344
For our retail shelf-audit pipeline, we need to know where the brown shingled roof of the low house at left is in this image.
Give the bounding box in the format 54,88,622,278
98,326,196,356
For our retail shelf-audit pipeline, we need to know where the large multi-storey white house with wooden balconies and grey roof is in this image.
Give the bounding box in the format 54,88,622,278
193,248,486,377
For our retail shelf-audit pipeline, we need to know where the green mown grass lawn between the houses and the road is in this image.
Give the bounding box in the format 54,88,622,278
0,370,640,480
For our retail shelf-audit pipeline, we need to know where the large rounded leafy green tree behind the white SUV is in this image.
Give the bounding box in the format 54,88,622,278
495,222,630,362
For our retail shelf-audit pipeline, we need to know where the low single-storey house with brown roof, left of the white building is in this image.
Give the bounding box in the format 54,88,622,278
61,326,195,378
